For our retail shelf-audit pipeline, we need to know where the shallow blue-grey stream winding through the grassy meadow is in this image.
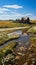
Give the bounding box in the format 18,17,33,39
0,30,30,49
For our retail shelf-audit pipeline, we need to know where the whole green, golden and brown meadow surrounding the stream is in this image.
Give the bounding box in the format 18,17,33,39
0,20,36,65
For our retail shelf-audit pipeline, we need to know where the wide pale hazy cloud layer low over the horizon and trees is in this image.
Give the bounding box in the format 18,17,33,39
0,9,36,20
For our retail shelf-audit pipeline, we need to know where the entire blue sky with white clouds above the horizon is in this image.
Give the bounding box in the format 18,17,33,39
0,0,36,20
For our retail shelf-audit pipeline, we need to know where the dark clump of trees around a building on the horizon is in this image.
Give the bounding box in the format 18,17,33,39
9,17,35,24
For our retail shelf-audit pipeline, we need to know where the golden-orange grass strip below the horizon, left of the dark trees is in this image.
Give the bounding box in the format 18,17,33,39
0,21,29,28
